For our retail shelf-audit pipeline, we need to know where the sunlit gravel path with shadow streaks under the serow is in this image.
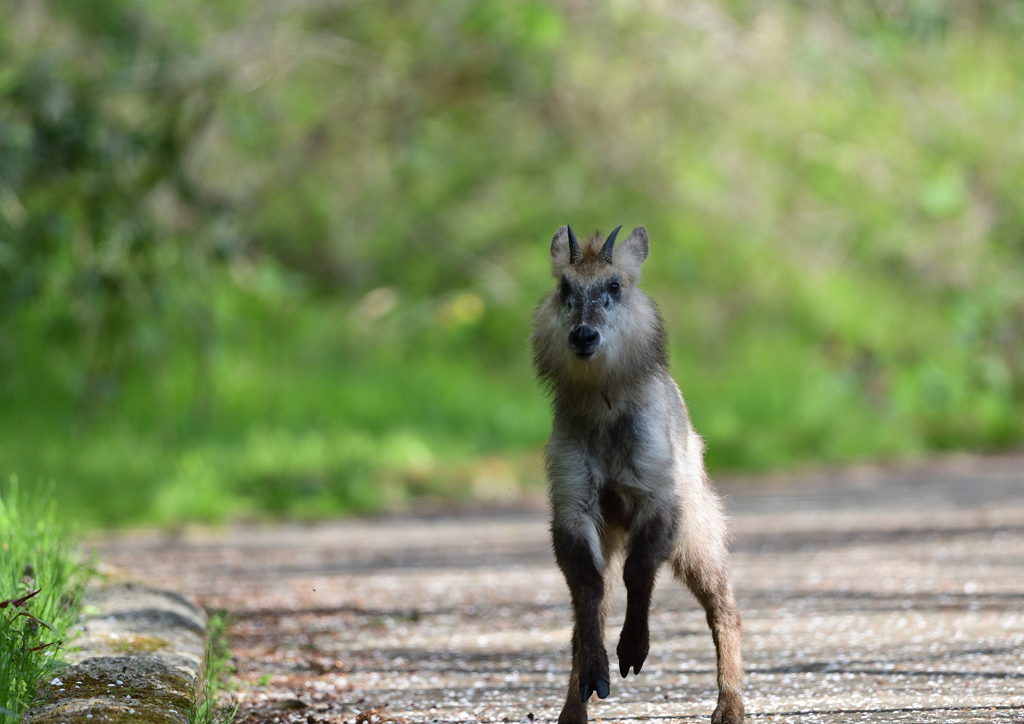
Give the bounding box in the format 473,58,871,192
94,457,1024,724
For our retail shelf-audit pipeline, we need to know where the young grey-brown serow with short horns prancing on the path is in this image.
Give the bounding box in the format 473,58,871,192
530,226,743,724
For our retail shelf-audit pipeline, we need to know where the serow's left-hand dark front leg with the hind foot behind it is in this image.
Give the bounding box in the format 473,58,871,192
552,527,610,724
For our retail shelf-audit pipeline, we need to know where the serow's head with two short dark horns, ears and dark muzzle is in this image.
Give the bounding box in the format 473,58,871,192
551,225,648,360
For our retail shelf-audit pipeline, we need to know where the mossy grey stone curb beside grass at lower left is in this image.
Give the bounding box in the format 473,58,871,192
23,582,207,724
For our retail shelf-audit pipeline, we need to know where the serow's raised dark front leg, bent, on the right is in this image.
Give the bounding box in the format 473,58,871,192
615,515,675,679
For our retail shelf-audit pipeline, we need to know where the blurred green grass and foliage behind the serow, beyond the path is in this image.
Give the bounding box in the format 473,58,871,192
0,0,1024,525
